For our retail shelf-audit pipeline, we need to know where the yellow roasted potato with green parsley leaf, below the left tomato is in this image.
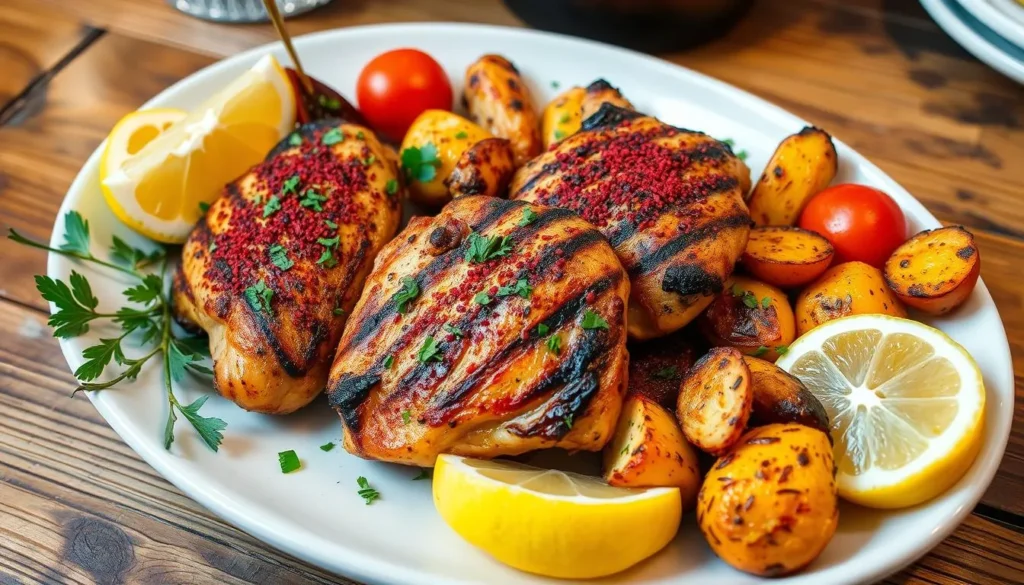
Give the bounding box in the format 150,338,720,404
399,110,492,206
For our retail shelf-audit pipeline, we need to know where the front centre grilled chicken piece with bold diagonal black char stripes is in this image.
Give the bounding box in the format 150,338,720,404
328,196,630,466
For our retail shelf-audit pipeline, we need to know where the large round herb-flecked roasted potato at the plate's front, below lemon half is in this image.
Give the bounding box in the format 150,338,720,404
697,424,839,577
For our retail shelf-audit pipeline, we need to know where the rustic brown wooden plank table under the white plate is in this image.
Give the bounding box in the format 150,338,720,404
0,0,1024,585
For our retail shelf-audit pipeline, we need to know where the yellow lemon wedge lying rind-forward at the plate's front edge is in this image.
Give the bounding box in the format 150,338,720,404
433,455,682,579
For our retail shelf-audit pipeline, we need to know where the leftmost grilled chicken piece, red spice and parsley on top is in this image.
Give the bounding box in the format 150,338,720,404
174,123,401,414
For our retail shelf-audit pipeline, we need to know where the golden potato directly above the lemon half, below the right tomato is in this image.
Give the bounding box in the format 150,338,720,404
796,262,906,335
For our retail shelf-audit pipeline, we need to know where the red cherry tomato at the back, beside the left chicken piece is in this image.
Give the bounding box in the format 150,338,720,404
355,49,452,140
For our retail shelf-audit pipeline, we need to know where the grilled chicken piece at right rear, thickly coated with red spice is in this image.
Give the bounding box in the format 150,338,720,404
509,103,751,339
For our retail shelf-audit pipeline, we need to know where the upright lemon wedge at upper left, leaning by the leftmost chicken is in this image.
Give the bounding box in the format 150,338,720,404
101,55,295,244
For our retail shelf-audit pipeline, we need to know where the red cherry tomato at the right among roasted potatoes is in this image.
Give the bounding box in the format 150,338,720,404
800,184,906,267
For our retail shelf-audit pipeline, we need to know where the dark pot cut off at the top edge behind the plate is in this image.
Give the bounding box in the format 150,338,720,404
504,0,754,53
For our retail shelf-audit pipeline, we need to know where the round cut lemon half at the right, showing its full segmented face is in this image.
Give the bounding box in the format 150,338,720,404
777,315,985,508
